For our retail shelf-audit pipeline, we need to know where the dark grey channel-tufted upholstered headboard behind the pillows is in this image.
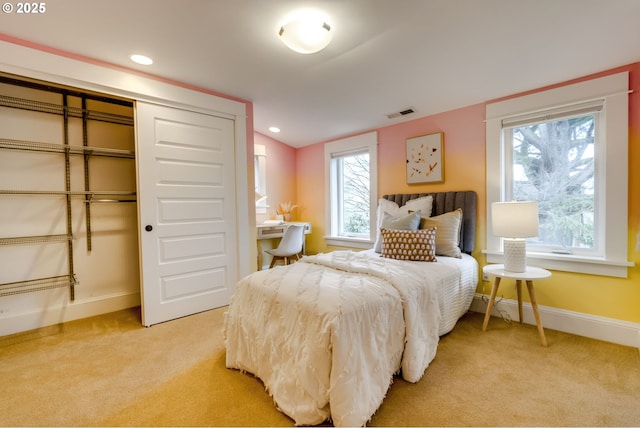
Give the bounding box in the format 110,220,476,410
383,190,477,254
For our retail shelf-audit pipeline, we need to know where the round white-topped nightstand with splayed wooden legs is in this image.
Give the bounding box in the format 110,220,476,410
482,265,551,346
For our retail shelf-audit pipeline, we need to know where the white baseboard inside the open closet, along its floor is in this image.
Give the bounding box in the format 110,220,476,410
0,292,140,336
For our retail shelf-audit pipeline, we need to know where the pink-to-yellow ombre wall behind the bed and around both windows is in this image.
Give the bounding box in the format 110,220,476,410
295,63,640,323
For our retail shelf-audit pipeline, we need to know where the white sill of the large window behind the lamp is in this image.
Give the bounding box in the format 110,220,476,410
482,250,635,278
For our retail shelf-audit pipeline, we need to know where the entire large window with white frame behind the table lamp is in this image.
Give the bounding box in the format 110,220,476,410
486,73,632,277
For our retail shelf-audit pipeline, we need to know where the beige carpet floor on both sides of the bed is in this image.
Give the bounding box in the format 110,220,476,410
0,308,640,426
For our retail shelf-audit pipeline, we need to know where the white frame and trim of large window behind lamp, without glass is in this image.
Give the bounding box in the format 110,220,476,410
484,72,634,278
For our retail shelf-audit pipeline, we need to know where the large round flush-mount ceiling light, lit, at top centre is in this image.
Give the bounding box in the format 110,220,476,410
278,11,331,54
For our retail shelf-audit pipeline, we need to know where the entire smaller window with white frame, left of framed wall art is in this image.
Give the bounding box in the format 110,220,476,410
325,132,378,248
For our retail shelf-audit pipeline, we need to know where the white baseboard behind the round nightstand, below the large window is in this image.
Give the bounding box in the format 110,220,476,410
471,294,640,349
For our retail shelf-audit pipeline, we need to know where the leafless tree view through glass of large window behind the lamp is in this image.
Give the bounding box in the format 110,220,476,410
505,114,597,252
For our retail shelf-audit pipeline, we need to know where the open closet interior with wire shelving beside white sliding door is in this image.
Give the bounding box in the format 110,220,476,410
0,74,140,334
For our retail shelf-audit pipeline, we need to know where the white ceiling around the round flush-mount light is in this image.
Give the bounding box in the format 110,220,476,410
0,0,640,147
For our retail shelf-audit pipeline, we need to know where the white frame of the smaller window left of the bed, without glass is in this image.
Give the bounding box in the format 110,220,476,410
324,132,378,249
